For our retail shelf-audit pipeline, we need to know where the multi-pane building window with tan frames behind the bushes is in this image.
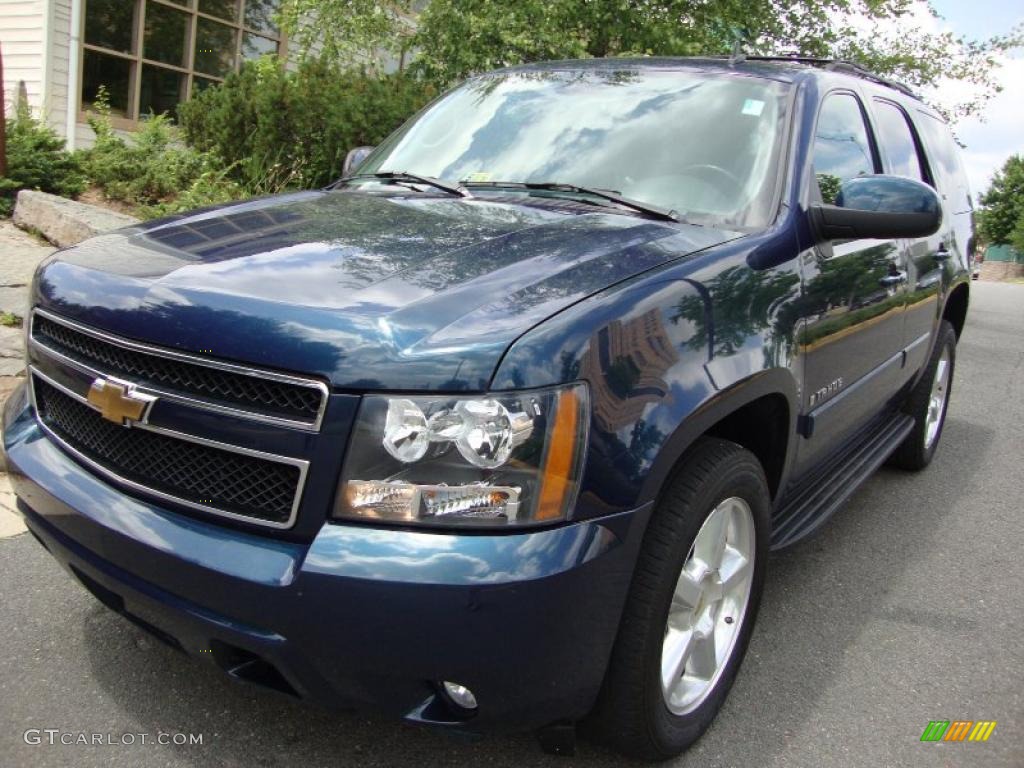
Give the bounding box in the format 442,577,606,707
81,0,285,127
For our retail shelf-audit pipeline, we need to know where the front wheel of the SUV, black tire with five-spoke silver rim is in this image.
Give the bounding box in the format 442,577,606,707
589,438,771,760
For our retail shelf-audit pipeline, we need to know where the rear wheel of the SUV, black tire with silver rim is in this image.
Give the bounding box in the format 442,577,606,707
889,321,956,471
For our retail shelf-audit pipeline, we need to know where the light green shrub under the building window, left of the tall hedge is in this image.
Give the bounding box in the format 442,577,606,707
81,94,248,217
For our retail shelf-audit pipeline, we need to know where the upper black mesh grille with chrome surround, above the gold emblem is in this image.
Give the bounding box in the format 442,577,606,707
32,309,327,429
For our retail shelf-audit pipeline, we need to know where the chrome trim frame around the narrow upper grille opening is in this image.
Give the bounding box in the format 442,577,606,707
27,307,330,432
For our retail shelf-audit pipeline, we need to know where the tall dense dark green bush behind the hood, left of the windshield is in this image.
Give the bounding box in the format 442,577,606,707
178,57,434,193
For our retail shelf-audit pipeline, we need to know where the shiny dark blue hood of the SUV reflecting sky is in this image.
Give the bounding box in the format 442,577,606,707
36,190,738,390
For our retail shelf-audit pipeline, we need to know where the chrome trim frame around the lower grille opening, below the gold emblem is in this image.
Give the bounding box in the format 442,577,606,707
29,366,309,530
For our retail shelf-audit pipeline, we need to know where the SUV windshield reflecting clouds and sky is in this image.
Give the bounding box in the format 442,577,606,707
357,69,786,228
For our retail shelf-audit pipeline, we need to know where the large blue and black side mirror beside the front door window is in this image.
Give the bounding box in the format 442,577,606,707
810,174,942,243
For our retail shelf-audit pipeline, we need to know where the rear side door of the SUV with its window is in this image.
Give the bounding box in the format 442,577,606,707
871,97,937,383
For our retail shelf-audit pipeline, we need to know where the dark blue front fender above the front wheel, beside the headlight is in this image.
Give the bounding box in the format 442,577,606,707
490,237,799,518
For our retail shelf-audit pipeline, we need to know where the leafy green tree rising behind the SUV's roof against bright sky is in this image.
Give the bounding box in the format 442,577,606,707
405,0,1022,117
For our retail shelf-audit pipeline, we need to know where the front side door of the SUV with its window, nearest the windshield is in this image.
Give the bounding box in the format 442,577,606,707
797,90,906,473
